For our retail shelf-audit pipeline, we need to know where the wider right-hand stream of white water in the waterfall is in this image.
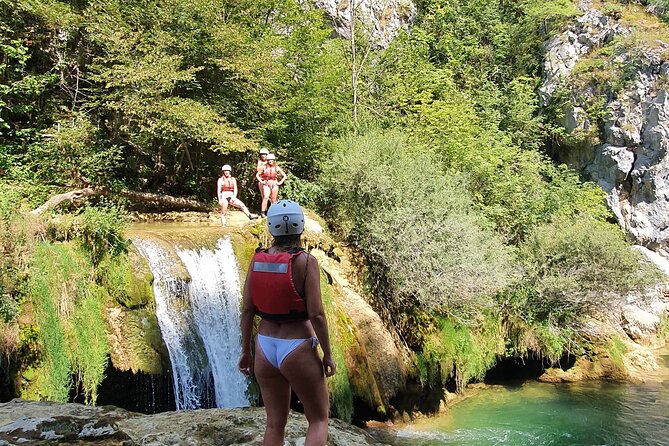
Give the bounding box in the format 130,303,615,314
177,238,249,407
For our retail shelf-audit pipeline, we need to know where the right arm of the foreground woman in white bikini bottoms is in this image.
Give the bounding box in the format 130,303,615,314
304,254,337,376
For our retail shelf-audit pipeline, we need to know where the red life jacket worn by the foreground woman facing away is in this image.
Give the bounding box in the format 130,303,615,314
251,249,308,320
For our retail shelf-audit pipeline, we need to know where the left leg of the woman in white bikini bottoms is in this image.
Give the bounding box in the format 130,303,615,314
253,341,290,446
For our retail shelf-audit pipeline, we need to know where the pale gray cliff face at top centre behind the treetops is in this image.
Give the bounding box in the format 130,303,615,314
314,0,416,48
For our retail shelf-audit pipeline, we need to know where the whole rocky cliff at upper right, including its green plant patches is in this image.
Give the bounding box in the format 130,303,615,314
541,1,669,272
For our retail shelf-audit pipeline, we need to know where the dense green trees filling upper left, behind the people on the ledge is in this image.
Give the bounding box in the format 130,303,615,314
0,0,346,202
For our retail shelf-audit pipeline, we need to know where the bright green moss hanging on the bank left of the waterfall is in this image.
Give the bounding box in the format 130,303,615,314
22,243,109,403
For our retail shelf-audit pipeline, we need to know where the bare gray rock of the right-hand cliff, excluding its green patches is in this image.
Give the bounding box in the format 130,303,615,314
541,2,669,262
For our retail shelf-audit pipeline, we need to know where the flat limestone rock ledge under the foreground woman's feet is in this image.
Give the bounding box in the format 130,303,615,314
0,399,383,446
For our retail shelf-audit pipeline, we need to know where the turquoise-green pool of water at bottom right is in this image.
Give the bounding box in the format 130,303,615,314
399,356,669,446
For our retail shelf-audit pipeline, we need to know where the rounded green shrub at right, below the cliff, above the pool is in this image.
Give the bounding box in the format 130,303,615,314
520,217,656,321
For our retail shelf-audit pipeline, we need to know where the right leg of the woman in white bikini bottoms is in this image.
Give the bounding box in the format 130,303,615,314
281,340,330,446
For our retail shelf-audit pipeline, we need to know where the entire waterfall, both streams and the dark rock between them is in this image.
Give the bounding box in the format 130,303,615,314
133,238,249,410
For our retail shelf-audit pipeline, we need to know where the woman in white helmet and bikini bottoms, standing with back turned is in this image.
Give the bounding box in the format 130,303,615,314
239,200,336,446
